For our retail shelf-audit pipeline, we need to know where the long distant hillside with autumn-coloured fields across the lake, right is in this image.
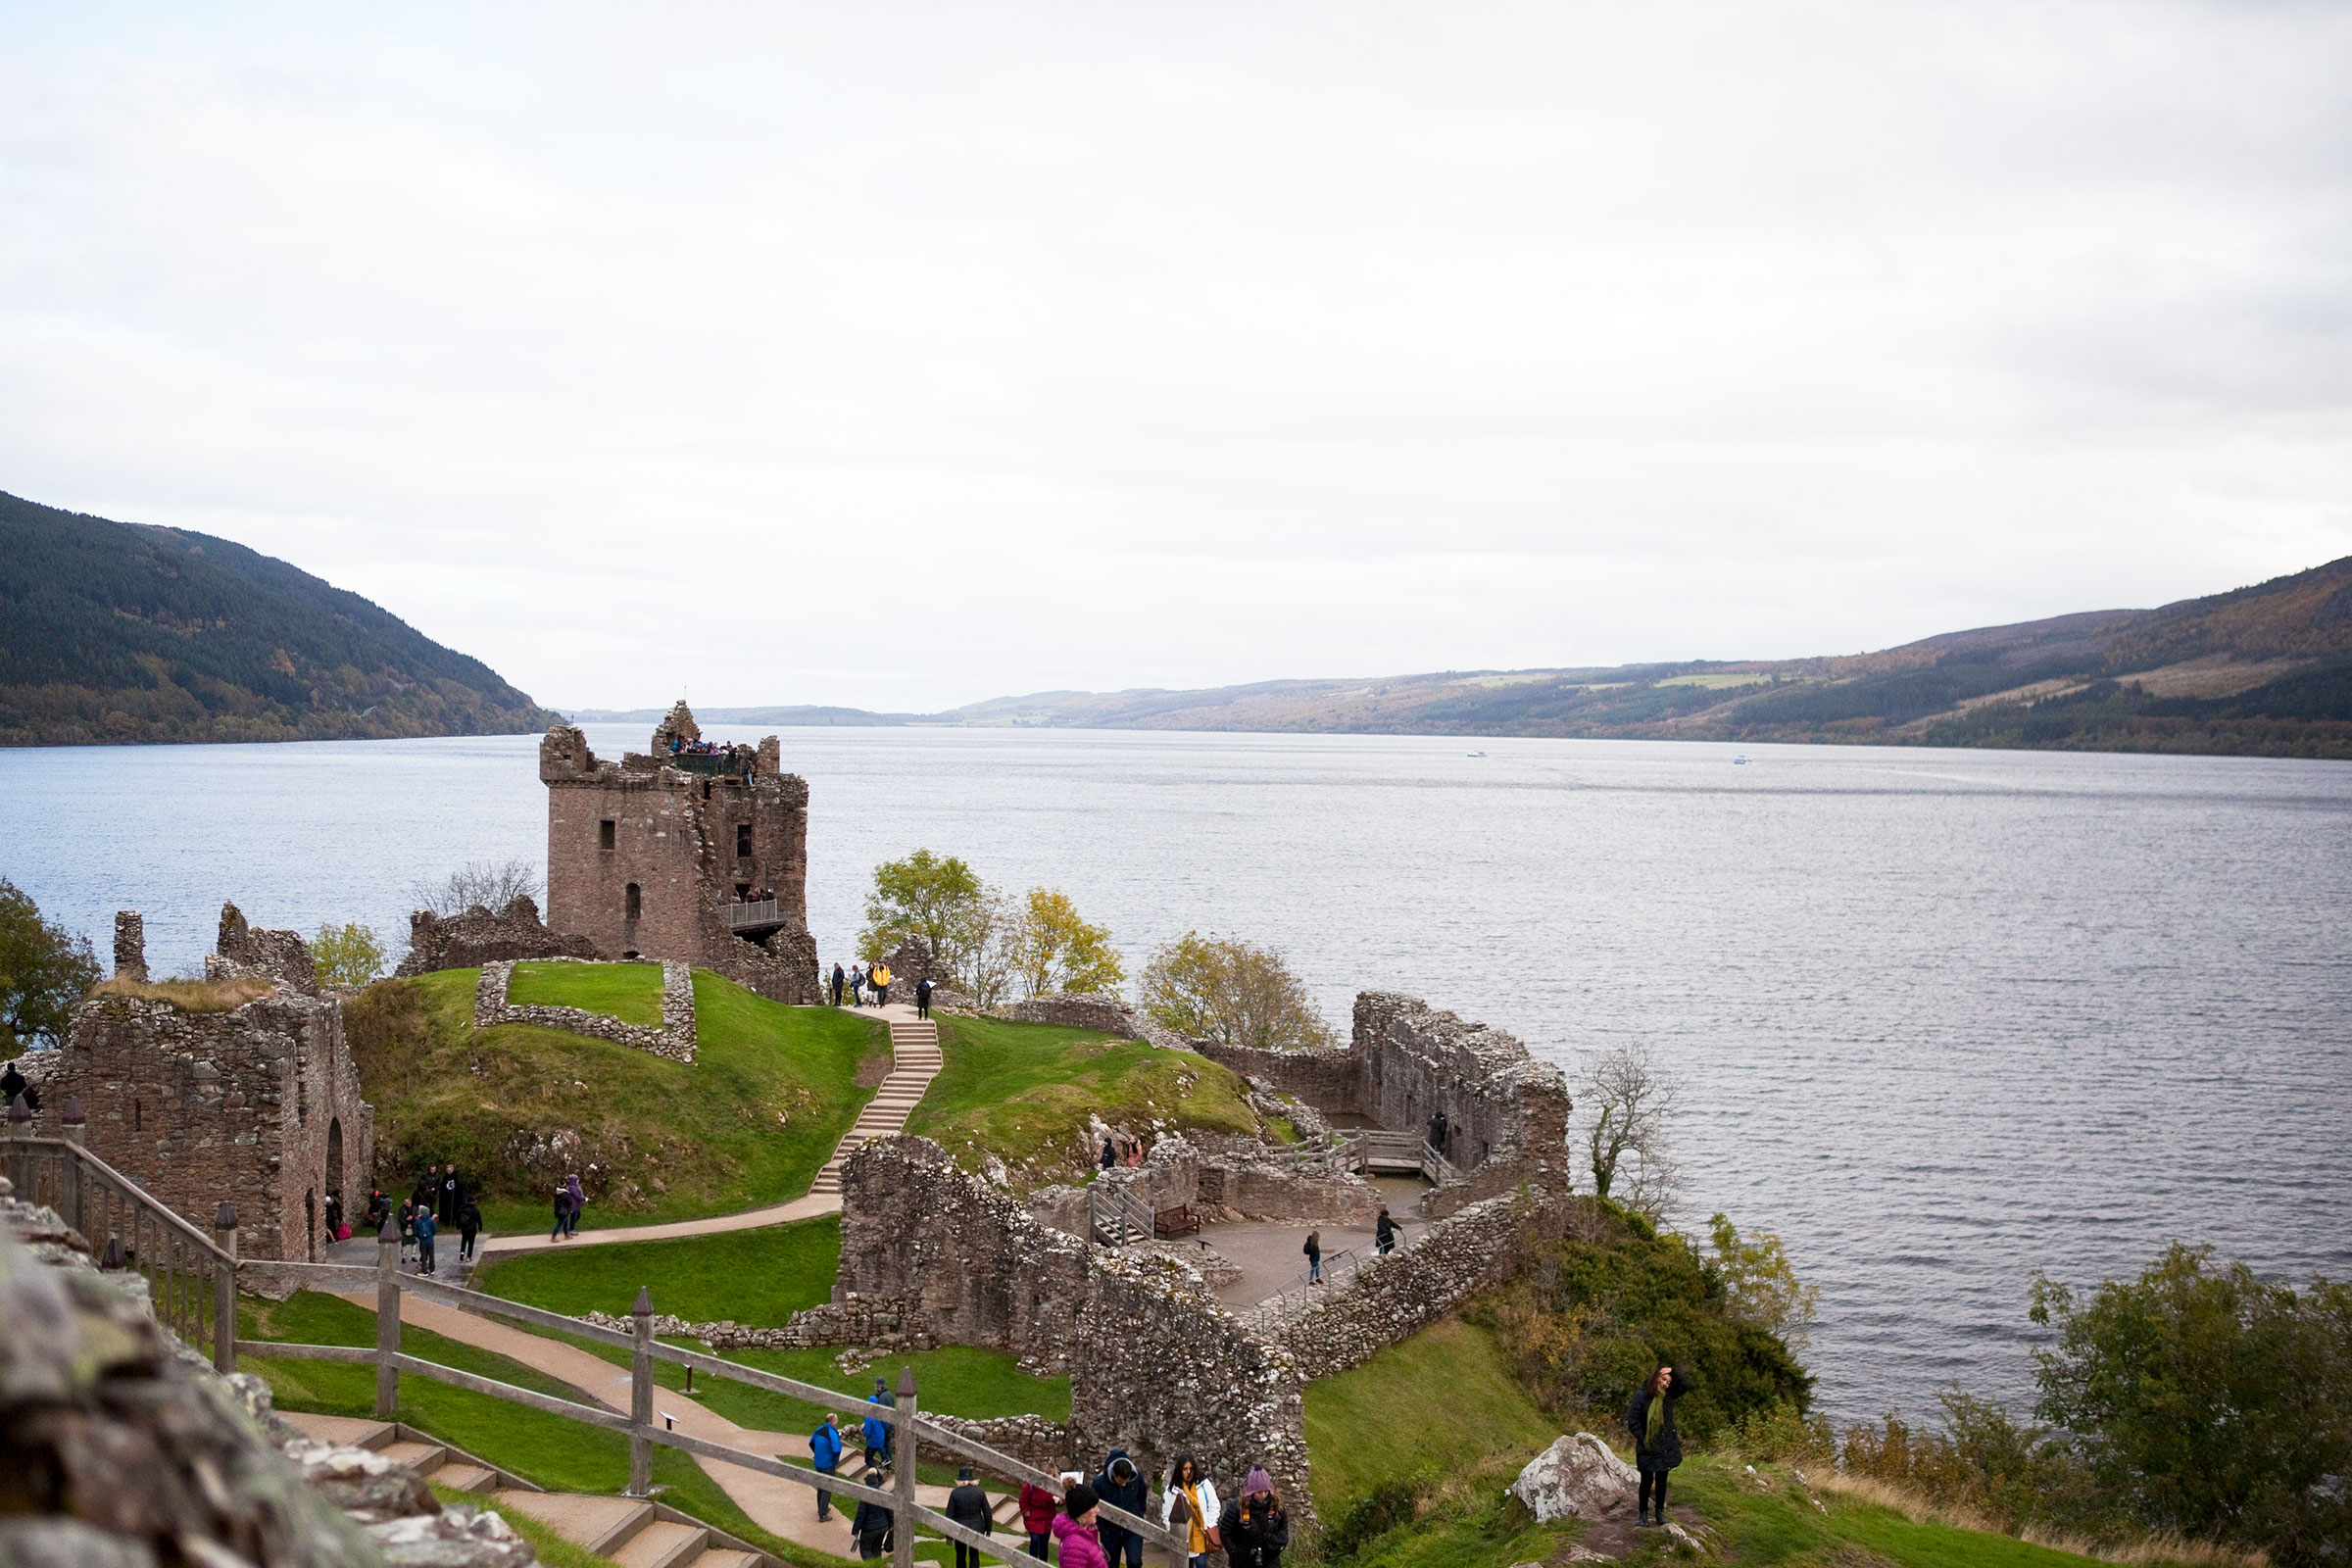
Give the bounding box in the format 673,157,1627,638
917,558,2352,760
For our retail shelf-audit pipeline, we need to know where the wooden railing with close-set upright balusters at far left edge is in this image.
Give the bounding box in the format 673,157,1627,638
0,1128,237,1373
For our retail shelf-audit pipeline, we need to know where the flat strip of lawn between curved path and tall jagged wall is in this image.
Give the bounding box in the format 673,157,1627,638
475,1215,842,1328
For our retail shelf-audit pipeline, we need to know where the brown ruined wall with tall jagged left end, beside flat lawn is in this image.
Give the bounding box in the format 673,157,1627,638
793,1138,1087,1359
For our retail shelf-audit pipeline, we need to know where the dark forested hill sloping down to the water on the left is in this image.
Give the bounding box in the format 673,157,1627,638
0,494,555,745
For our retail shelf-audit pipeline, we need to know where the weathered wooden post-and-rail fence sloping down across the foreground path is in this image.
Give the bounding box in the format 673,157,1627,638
235,1225,1186,1568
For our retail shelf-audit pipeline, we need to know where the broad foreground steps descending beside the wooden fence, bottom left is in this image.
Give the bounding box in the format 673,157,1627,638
280,1410,766,1568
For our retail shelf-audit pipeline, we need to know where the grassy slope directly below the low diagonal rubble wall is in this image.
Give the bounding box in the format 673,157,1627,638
1305,1316,1559,1523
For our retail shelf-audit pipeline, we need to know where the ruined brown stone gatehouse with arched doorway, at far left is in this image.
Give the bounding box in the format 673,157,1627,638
45,990,376,1260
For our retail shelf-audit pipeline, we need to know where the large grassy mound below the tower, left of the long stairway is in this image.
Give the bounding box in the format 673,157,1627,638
343,964,889,1232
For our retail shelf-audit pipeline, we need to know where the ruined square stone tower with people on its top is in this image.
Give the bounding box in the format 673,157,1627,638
539,701,816,1004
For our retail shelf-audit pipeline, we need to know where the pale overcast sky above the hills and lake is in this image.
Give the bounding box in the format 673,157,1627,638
0,0,2352,710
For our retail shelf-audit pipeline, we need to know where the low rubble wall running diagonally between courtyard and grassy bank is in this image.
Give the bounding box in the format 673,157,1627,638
1272,1185,1574,1380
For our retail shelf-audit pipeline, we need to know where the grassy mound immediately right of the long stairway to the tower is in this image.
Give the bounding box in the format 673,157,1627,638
906,1018,1282,1192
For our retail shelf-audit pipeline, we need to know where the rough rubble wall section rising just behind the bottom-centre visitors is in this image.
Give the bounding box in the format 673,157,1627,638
1070,1249,1312,1523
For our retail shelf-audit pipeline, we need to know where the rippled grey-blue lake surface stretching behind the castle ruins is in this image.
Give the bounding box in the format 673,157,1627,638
0,726,2352,1420
